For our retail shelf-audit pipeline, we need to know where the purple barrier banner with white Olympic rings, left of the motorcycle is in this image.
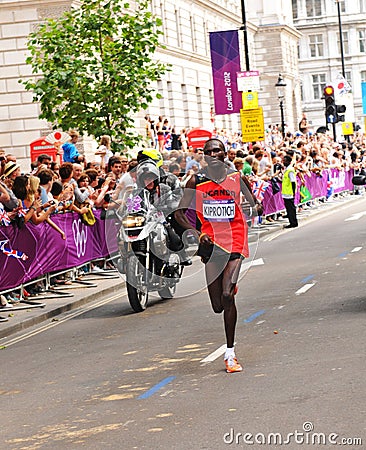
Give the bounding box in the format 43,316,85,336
0,211,117,291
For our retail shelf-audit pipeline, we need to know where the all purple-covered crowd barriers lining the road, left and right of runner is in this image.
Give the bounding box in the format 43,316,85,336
0,169,353,293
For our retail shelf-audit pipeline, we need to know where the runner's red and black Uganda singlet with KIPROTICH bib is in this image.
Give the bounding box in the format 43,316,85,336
196,172,249,258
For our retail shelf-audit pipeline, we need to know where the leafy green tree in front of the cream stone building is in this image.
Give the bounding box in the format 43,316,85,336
23,0,168,150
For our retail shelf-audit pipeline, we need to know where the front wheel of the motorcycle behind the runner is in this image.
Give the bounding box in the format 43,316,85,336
126,256,148,312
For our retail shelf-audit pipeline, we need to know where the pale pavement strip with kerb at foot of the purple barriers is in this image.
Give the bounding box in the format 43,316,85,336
0,193,364,342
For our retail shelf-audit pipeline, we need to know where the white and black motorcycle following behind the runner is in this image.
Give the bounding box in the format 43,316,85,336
111,187,183,312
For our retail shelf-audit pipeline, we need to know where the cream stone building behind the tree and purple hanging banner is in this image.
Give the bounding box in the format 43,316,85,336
0,0,301,166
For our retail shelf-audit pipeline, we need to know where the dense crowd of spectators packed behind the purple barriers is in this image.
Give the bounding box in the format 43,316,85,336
0,116,366,314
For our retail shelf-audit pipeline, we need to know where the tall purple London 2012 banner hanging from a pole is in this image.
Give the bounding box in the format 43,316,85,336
210,30,242,114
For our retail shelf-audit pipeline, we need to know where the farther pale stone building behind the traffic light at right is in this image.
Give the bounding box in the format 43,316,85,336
292,0,366,134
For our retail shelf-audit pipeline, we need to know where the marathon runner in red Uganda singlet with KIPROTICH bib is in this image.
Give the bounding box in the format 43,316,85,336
175,139,260,373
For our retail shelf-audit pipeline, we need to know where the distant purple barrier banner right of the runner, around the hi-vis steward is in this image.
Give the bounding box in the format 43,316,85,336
263,169,353,215
